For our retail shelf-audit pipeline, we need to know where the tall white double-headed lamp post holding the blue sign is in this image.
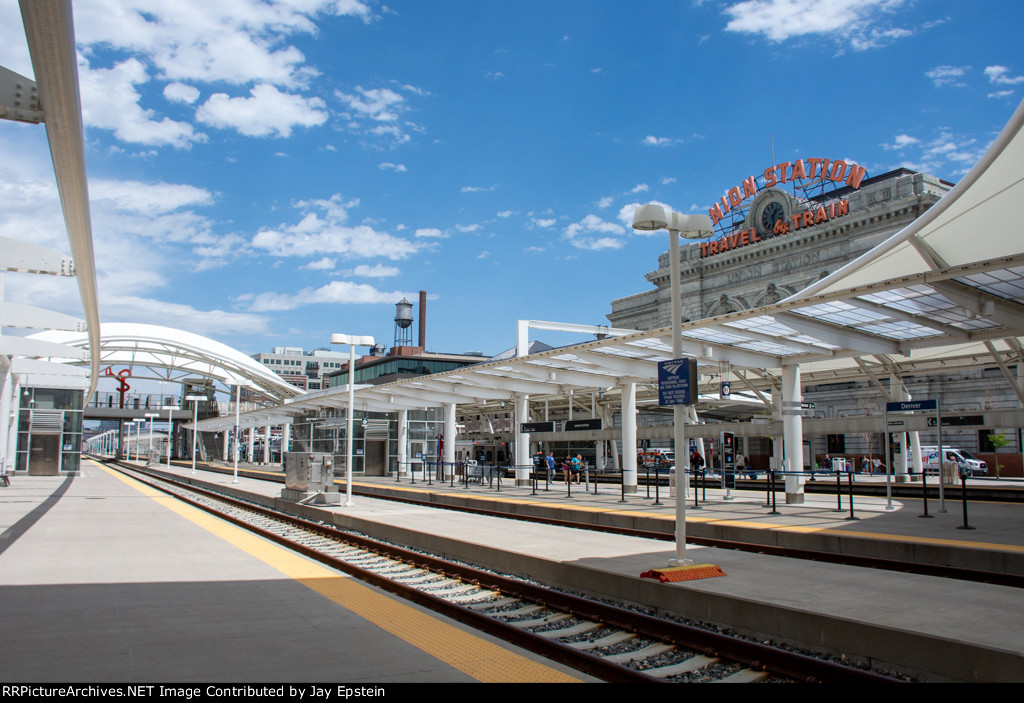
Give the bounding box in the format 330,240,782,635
633,203,713,566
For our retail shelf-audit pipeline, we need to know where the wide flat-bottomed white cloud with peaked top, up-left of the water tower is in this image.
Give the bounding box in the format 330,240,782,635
251,194,420,260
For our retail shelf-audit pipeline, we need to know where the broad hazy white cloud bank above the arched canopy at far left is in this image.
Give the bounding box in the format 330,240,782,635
0,153,251,319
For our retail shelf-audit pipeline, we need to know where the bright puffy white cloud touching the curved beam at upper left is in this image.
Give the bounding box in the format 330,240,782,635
78,58,206,148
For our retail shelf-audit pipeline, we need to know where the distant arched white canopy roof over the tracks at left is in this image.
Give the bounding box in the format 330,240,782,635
30,322,301,402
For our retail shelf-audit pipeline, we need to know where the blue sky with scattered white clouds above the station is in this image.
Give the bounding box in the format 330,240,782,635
0,0,1024,362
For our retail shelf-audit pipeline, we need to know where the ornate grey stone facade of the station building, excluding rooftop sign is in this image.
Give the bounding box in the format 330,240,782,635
607,169,1022,467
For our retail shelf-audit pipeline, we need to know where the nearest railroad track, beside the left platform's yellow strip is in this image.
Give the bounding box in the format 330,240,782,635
108,462,897,683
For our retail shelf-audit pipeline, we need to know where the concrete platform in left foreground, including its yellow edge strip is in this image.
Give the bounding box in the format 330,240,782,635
0,462,580,684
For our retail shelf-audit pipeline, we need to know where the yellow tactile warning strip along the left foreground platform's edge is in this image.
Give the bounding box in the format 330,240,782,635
92,463,579,684
